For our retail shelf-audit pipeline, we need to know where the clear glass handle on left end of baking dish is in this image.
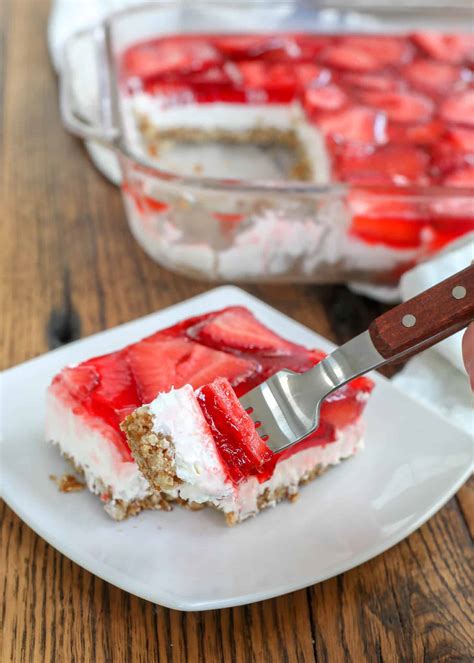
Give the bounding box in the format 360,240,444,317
59,26,118,147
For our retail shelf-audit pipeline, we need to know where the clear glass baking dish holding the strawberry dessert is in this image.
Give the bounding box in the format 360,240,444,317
61,2,474,285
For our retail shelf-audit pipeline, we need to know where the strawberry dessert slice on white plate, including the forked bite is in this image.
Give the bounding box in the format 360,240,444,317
46,307,373,524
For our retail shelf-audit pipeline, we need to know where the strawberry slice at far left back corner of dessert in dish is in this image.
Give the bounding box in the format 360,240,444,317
123,37,221,80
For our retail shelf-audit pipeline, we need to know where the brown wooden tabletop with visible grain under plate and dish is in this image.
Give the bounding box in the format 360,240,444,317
0,0,473,663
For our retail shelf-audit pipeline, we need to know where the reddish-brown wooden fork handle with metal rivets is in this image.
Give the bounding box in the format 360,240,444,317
369,265,474,359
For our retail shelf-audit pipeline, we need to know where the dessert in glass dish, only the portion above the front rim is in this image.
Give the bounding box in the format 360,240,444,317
122,33,474,185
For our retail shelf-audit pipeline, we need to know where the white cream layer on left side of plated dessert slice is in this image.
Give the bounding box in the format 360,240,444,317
46,387,153,503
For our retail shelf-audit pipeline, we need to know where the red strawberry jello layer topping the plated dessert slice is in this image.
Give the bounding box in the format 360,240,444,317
52,306,373,481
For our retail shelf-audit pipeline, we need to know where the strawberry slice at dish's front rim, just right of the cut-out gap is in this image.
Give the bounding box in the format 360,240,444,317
338,145,429,184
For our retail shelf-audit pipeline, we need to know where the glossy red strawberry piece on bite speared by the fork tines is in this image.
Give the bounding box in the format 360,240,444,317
198,378,273,481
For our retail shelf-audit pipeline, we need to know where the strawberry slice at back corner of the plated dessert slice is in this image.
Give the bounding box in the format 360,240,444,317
188,306,307,356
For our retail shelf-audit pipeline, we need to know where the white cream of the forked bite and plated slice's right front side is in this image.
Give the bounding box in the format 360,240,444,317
147,385,363,520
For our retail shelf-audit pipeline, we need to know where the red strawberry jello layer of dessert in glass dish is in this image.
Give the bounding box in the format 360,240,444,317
121,32,474,252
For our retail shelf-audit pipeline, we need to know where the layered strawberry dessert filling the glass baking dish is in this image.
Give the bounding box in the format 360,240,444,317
121,33,474,282
